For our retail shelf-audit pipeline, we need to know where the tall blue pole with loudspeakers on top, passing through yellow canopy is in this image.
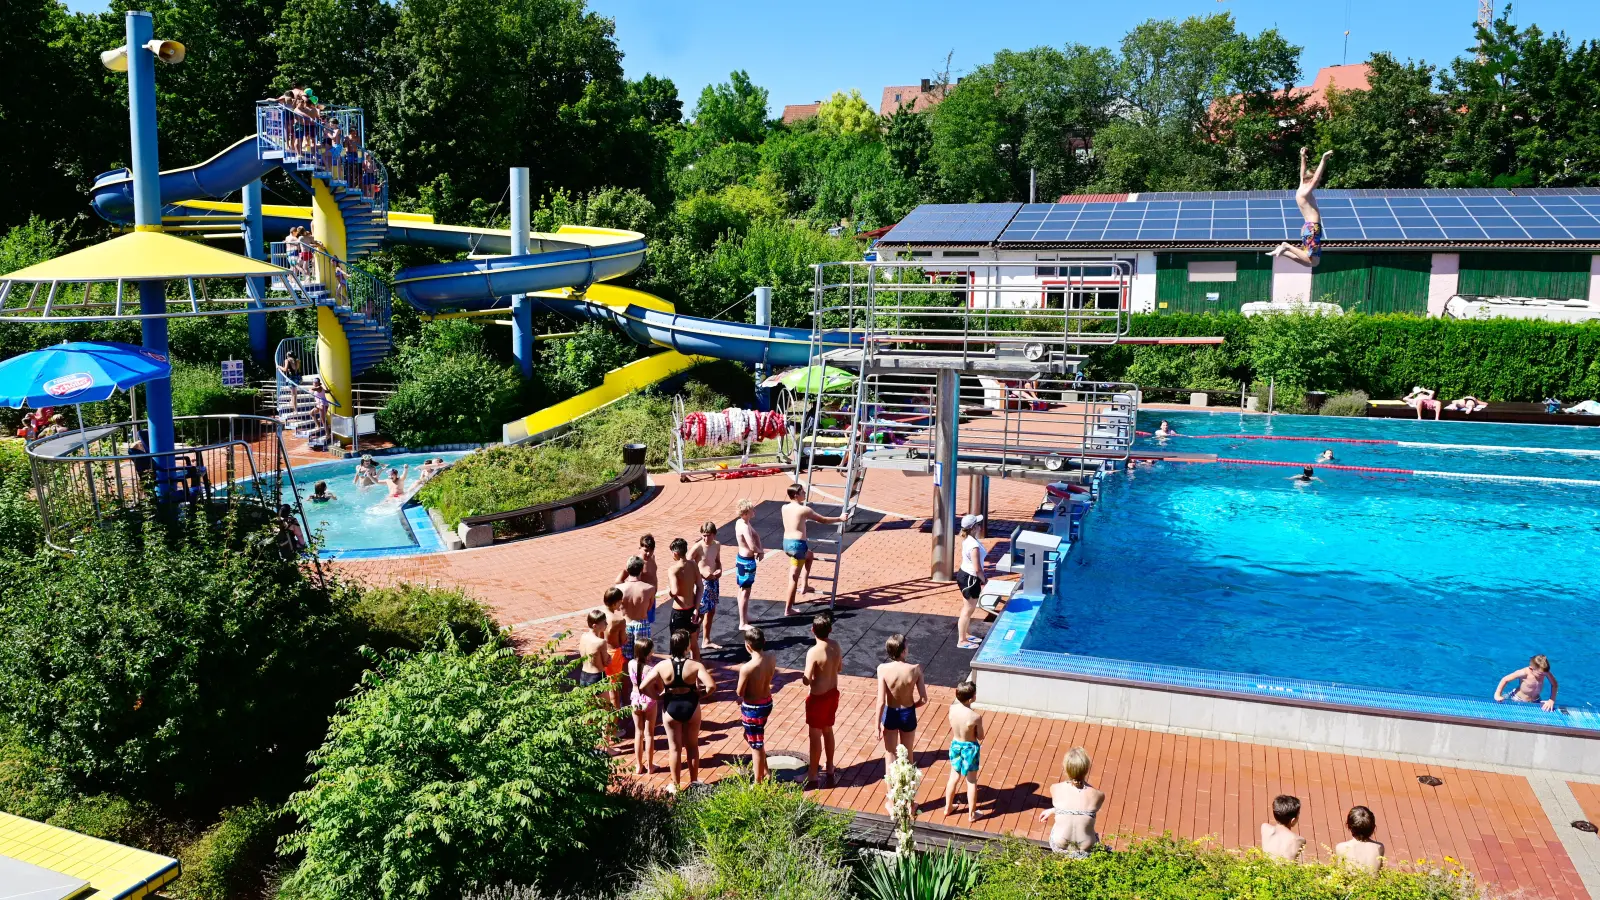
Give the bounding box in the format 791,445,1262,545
126,11,174,490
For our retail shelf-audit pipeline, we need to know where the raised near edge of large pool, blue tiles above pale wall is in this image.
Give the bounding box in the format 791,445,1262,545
971,597,1600,775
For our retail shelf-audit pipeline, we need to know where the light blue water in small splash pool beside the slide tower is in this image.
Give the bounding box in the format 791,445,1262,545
294,452,464,552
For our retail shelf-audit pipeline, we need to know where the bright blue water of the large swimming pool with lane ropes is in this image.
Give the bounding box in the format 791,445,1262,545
1024,412,1600,708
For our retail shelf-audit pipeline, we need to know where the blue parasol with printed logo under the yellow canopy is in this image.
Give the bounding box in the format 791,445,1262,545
0,341,173,410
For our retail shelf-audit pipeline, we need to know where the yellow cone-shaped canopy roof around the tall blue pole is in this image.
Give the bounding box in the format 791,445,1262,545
0,231,285,282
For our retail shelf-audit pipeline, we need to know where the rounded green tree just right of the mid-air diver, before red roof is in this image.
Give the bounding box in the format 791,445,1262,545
1317,53,1450,187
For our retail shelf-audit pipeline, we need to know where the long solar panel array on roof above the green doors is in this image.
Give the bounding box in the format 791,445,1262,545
992,191,1600,243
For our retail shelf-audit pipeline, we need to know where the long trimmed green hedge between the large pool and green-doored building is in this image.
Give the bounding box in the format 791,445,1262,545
1091,314,1600,400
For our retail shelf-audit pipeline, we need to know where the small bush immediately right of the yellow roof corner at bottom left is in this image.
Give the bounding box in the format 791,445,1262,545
168,801,283,900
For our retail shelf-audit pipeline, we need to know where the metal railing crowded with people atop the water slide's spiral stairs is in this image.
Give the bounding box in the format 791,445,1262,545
256,99,389,215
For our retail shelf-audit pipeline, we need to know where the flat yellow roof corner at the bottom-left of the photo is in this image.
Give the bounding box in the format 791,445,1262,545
0,812,178,900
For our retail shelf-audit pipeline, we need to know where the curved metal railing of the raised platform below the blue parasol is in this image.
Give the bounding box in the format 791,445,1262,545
27,415,310,551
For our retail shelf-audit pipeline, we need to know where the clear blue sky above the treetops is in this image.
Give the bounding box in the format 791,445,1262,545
67,0,1600,114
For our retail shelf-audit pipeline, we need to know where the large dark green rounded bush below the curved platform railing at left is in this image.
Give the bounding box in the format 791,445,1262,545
0,517,358,812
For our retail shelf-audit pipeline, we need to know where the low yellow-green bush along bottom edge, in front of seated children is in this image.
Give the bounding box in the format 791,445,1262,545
971,834,1478,900
